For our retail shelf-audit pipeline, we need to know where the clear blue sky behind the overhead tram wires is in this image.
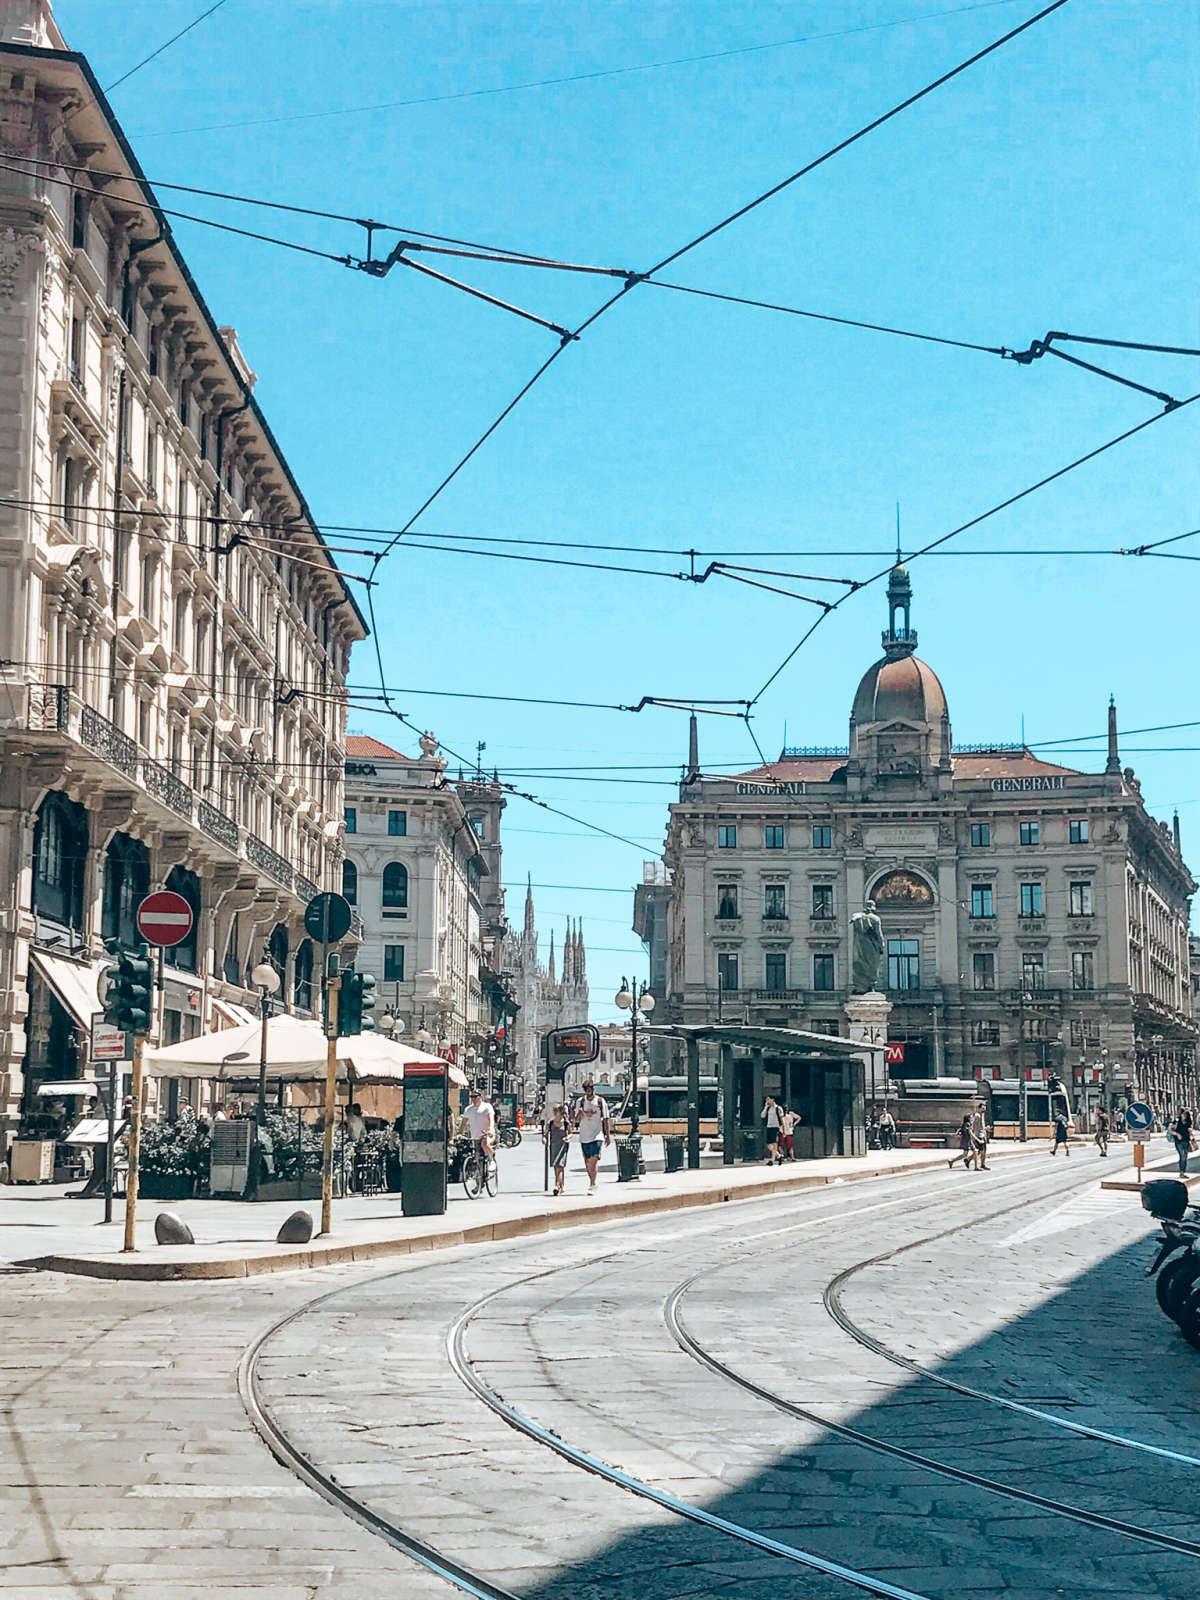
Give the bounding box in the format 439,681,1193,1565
56,0,1200,1021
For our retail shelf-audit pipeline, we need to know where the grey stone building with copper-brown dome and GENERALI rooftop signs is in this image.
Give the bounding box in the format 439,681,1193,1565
662,566,1197,1106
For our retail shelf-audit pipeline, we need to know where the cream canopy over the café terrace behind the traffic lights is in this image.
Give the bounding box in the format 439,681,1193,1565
144,1013,466,1083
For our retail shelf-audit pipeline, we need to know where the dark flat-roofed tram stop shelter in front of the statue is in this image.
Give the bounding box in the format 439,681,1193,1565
638,1022,869,1168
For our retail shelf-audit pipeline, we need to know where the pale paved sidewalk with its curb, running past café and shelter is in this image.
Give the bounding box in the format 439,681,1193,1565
0,1141,1045,1280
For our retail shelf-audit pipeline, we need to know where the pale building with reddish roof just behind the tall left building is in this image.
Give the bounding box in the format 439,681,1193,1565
342,733,494,1058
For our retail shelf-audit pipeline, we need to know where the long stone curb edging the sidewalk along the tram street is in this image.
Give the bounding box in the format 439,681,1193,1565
16,1149,1021,1283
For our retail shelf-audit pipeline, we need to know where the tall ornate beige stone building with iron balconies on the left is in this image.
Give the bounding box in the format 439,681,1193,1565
0,0,366,1142
